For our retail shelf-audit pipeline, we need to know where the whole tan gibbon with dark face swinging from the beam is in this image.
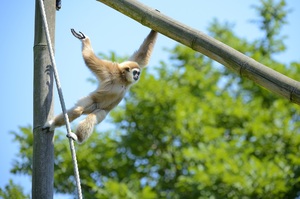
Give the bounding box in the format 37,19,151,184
43,29,157,143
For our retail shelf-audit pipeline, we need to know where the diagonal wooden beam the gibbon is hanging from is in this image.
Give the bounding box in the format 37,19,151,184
97,0,300,105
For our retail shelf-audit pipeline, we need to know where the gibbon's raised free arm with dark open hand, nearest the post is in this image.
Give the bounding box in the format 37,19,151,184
71,29,115,79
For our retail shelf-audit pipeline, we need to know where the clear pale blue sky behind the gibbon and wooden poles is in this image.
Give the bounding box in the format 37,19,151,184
0,0,300,197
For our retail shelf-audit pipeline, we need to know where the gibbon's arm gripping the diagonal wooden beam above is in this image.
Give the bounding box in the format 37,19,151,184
129,30,157,68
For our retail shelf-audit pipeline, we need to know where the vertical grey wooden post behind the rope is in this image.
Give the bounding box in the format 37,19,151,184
32,0,56,199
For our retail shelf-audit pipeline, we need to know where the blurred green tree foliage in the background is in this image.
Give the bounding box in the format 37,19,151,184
4,0,300,199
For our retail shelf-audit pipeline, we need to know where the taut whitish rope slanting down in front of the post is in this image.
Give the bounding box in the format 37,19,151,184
39,0,82,199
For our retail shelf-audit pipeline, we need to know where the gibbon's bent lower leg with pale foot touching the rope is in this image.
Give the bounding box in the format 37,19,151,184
76,109,108,143
